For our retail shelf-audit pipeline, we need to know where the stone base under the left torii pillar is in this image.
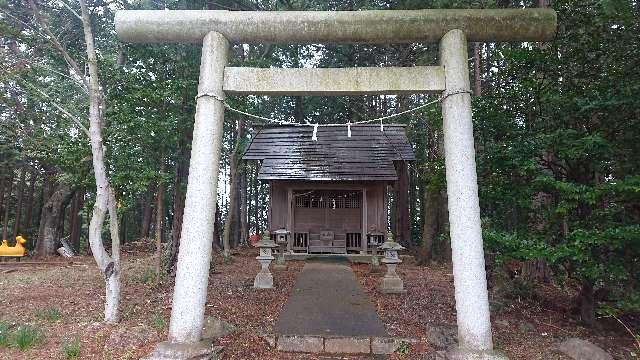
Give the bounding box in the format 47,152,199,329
143,340,223,360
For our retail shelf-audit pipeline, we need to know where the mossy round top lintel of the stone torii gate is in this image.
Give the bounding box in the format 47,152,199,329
115,8,557,44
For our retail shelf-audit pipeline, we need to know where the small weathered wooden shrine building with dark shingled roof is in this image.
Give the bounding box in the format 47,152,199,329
243,125,415,254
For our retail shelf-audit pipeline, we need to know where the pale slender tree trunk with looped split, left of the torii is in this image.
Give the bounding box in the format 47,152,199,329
80,0,120,323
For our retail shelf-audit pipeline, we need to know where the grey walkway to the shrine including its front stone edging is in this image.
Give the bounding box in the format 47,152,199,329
275,258,389,353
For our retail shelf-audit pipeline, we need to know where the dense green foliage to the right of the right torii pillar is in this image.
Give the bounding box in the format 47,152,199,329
474,0,640,311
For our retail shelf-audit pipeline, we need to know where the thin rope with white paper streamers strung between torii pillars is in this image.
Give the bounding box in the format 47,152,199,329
196,89,472,141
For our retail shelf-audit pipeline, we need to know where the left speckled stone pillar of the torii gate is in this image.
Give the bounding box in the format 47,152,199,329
165,32,229,358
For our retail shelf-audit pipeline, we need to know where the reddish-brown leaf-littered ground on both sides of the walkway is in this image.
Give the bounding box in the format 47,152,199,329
0,244,633,360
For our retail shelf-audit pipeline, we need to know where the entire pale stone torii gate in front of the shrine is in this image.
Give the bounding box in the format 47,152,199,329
115,9,556,359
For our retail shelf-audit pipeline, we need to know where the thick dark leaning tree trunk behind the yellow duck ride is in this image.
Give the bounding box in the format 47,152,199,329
35,184,74,258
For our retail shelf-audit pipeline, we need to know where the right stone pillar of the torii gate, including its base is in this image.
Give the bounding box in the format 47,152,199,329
440,30,498,360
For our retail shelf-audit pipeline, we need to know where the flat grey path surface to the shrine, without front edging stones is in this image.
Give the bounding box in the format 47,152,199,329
275,259,386,337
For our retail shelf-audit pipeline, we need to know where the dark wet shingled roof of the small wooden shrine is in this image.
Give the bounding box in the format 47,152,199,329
243,125,415,181
